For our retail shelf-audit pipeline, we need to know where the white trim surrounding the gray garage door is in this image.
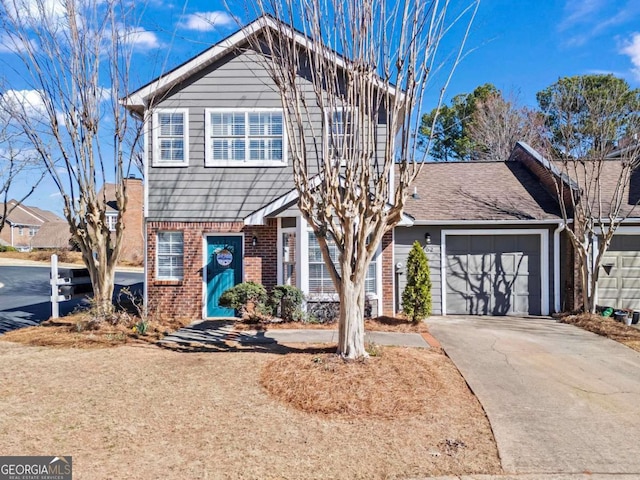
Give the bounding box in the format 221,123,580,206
440,228,549,315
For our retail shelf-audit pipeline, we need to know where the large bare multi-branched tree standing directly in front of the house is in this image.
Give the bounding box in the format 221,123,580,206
248,0,477,358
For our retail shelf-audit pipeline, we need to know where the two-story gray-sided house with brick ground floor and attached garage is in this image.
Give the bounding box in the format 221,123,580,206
125,16,640,318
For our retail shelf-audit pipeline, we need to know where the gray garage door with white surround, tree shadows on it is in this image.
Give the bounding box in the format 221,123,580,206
441,230,549,315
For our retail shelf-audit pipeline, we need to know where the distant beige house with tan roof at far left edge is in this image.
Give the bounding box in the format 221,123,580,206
0,200,68,251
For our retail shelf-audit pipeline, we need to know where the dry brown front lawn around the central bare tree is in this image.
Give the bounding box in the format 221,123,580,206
0,341,500,480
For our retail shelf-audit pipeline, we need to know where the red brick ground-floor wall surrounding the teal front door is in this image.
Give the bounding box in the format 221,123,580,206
146,220,277,320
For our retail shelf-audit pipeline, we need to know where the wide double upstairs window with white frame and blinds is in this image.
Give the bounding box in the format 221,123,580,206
205,109,286,166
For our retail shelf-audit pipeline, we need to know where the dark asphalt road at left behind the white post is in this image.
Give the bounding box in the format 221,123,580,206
0,266,144,335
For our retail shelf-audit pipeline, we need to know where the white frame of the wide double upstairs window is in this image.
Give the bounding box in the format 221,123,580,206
204,108,289,167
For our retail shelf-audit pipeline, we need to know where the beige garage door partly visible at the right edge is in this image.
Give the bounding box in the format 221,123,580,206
598,233,640,310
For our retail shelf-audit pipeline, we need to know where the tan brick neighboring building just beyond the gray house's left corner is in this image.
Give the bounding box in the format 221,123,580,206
98,175,144,264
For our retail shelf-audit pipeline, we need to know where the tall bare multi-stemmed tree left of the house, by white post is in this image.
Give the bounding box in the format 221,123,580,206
0,0,140,315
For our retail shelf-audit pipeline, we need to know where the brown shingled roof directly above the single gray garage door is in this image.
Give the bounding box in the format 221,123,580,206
405,161,561,223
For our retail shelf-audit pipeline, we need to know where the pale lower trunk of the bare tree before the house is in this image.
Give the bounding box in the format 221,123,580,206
338,274,369,359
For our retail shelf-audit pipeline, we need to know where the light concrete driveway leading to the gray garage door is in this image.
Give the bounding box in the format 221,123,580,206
427,316,640,478
